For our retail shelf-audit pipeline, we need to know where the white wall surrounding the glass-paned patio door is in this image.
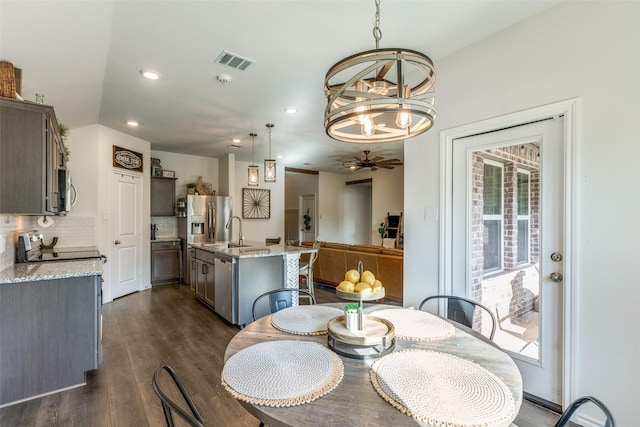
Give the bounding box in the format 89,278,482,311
404,2,640,426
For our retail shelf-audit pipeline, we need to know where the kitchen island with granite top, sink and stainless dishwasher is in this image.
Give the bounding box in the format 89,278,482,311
191,241,316,327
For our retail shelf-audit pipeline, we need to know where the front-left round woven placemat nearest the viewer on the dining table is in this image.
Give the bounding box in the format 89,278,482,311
222,341,344,407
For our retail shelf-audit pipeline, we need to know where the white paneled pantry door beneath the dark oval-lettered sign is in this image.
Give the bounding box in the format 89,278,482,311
109,172,143,298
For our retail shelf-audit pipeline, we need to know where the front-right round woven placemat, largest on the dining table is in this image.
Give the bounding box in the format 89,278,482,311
370,350,516,427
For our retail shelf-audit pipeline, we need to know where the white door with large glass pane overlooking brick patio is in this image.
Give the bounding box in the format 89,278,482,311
451,118,564,405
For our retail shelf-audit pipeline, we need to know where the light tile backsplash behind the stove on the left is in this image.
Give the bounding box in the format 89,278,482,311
0,215,97,270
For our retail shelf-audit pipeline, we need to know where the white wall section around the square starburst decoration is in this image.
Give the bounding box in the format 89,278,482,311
232,161,285,242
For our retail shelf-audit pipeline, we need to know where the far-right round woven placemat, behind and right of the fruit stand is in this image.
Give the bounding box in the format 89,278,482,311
372,308,456,341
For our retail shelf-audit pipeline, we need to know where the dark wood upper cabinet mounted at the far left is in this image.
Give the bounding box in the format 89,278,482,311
0,98,70,215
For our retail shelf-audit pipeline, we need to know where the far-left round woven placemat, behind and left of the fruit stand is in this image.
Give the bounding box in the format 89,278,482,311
271,305,342,335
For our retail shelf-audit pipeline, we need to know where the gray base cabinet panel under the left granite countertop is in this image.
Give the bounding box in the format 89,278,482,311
0,275,102,405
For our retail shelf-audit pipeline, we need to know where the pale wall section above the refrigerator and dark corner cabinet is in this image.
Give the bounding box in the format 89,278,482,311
151,150,223,199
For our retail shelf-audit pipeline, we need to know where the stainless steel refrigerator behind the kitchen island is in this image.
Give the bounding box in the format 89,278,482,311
178,195,233,283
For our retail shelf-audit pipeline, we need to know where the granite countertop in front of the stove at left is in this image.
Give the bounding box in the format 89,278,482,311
0,259,102,285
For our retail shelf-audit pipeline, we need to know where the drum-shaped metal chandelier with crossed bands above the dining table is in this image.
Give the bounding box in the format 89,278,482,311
324,0,436,143
